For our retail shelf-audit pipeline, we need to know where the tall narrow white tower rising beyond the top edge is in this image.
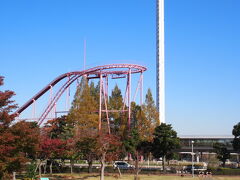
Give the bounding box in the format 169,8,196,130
156,0,165,123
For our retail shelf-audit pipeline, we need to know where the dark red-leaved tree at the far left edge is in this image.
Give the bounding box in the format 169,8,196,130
0,76,39,179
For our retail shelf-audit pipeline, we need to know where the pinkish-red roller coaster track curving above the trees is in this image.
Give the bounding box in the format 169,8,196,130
15,64,146,128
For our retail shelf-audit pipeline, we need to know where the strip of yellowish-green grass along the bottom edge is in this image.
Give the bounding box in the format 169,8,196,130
42,174,240,180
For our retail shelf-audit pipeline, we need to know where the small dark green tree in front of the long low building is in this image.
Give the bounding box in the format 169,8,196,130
213,143,230,167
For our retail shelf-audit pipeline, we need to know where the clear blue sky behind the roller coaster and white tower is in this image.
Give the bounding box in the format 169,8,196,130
0,0,240,135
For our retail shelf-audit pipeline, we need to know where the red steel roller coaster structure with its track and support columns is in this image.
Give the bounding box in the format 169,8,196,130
15,64,147,133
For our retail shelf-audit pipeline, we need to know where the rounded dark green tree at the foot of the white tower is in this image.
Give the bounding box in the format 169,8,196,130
152,123,180,171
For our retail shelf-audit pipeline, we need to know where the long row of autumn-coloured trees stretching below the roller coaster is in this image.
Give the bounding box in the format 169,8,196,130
0,77,179,179
